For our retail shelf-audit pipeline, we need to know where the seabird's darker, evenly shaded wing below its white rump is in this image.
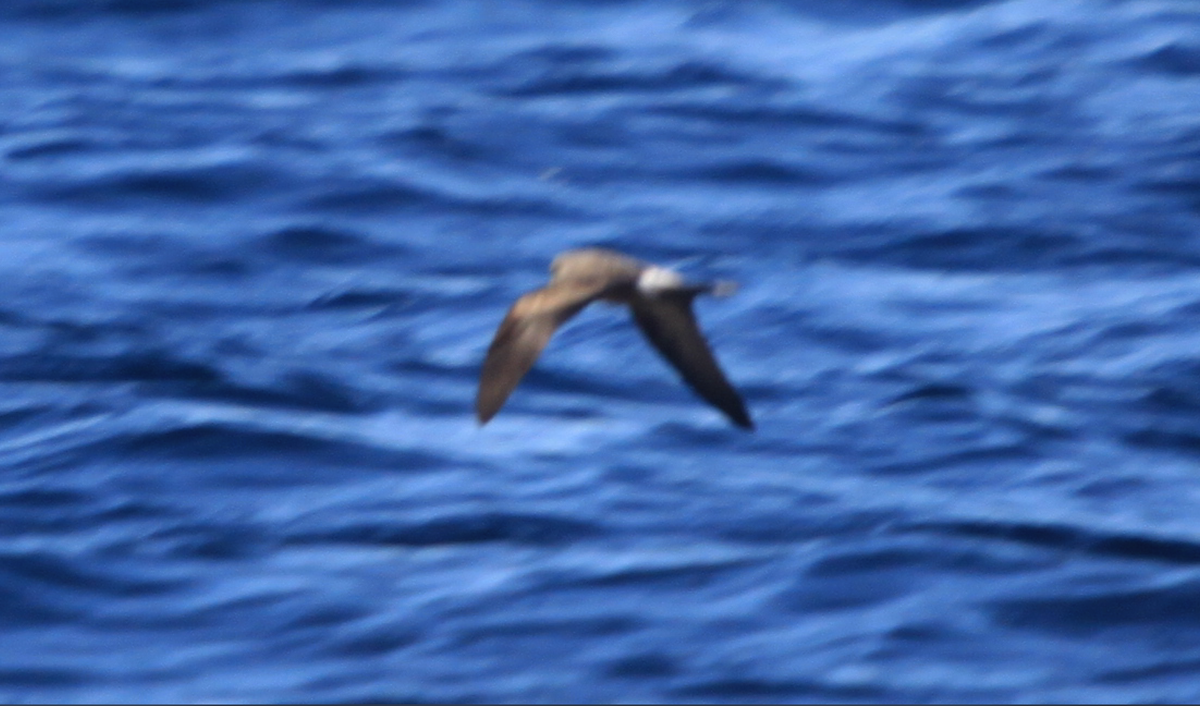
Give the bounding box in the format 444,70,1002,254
630,293,754,429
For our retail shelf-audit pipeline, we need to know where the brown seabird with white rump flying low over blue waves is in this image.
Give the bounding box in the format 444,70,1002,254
475,247,754,430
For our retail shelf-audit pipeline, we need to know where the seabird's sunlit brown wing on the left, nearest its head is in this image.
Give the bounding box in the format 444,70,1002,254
475,283,604,424
